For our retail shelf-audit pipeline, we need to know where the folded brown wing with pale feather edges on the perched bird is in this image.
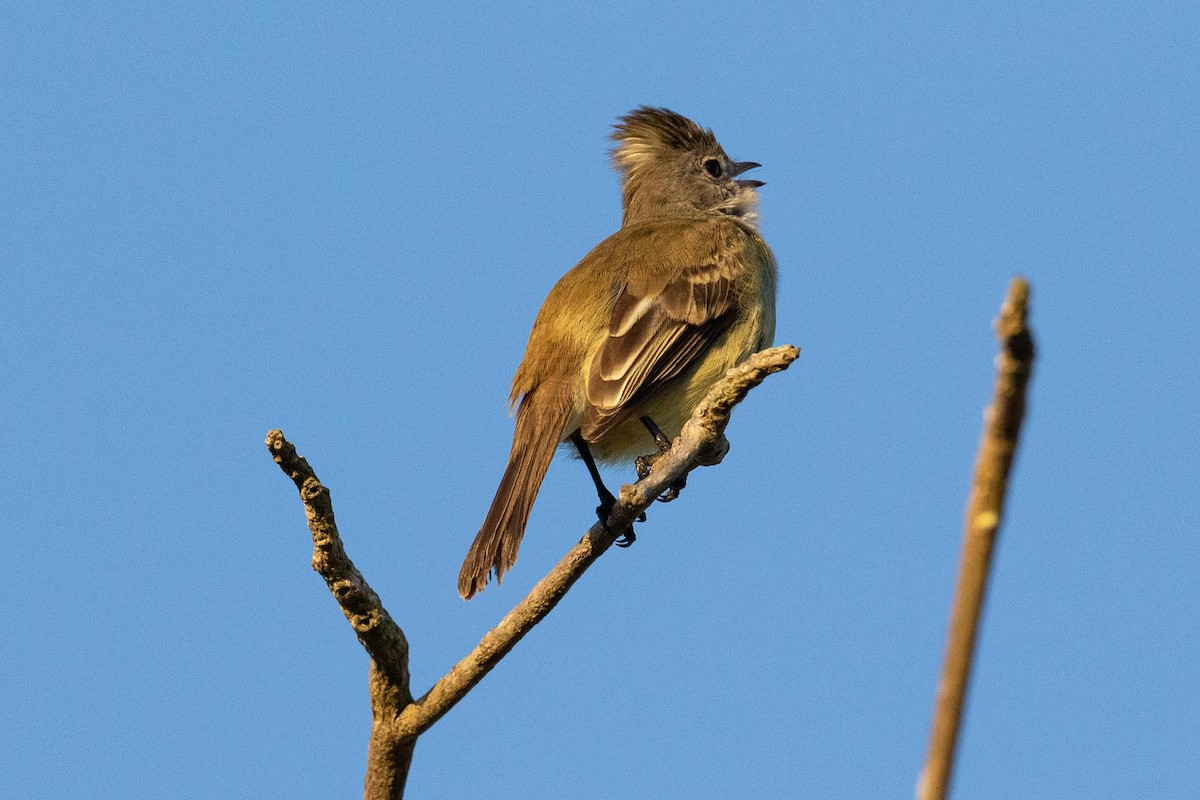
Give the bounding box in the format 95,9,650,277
582,221,748,440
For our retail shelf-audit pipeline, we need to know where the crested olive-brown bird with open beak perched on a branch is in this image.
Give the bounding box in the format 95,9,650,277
458,106,776,600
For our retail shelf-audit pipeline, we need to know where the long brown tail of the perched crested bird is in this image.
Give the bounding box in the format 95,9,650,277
458,385,571,600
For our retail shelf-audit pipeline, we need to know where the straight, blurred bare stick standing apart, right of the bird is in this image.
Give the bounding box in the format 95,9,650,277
917,278,1033,800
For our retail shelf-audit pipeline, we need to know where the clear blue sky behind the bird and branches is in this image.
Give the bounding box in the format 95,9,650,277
0,2,1200,799
